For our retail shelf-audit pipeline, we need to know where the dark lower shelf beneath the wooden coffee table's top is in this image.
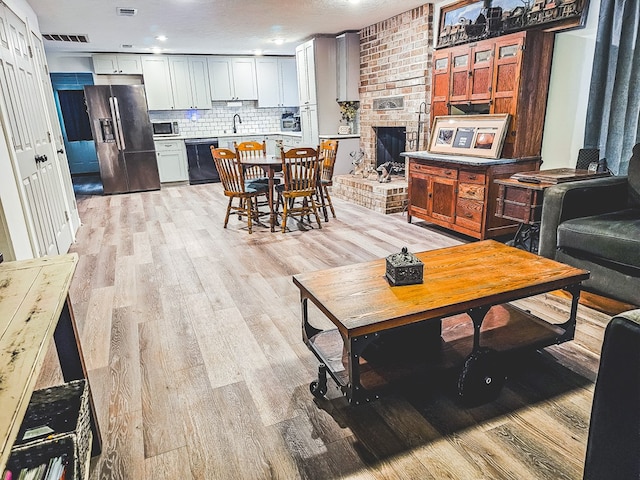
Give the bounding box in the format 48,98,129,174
306,304,575,405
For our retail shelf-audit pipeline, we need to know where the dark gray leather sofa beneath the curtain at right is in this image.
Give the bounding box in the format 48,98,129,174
538,144,640,305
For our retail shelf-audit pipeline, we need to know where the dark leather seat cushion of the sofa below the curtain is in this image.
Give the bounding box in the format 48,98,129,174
558,208,640,268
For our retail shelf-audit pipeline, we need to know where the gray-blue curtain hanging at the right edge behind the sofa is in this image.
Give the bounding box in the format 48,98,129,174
584,0,640,175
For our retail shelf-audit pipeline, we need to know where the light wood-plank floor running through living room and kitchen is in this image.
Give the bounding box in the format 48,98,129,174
40,184,610,480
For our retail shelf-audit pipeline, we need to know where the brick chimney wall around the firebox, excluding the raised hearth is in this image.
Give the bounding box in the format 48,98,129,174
359,4,433,171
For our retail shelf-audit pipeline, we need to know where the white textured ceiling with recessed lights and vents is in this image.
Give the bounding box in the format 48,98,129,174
27,0,427,55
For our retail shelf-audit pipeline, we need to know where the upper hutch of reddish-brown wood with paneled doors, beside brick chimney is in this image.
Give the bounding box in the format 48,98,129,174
431,30,554,158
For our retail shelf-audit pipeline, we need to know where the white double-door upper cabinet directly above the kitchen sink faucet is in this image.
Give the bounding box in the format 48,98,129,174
208,57,258,101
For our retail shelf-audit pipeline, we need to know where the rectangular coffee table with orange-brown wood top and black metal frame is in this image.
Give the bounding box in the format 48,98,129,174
293,240,589,405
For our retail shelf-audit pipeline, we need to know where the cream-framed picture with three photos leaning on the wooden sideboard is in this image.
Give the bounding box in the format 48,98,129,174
429,114,509,158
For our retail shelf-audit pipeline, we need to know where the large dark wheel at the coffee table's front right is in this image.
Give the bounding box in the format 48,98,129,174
458,348,507,405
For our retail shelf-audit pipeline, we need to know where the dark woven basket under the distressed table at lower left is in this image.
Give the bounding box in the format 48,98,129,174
7,380,92,480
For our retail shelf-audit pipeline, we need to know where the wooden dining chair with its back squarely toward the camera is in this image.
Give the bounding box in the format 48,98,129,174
276,147,322,233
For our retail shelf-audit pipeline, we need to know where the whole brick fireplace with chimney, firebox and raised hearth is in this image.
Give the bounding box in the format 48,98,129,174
333,4,433,213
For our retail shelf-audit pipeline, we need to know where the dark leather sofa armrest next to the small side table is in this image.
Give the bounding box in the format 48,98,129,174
538,176,627,259
